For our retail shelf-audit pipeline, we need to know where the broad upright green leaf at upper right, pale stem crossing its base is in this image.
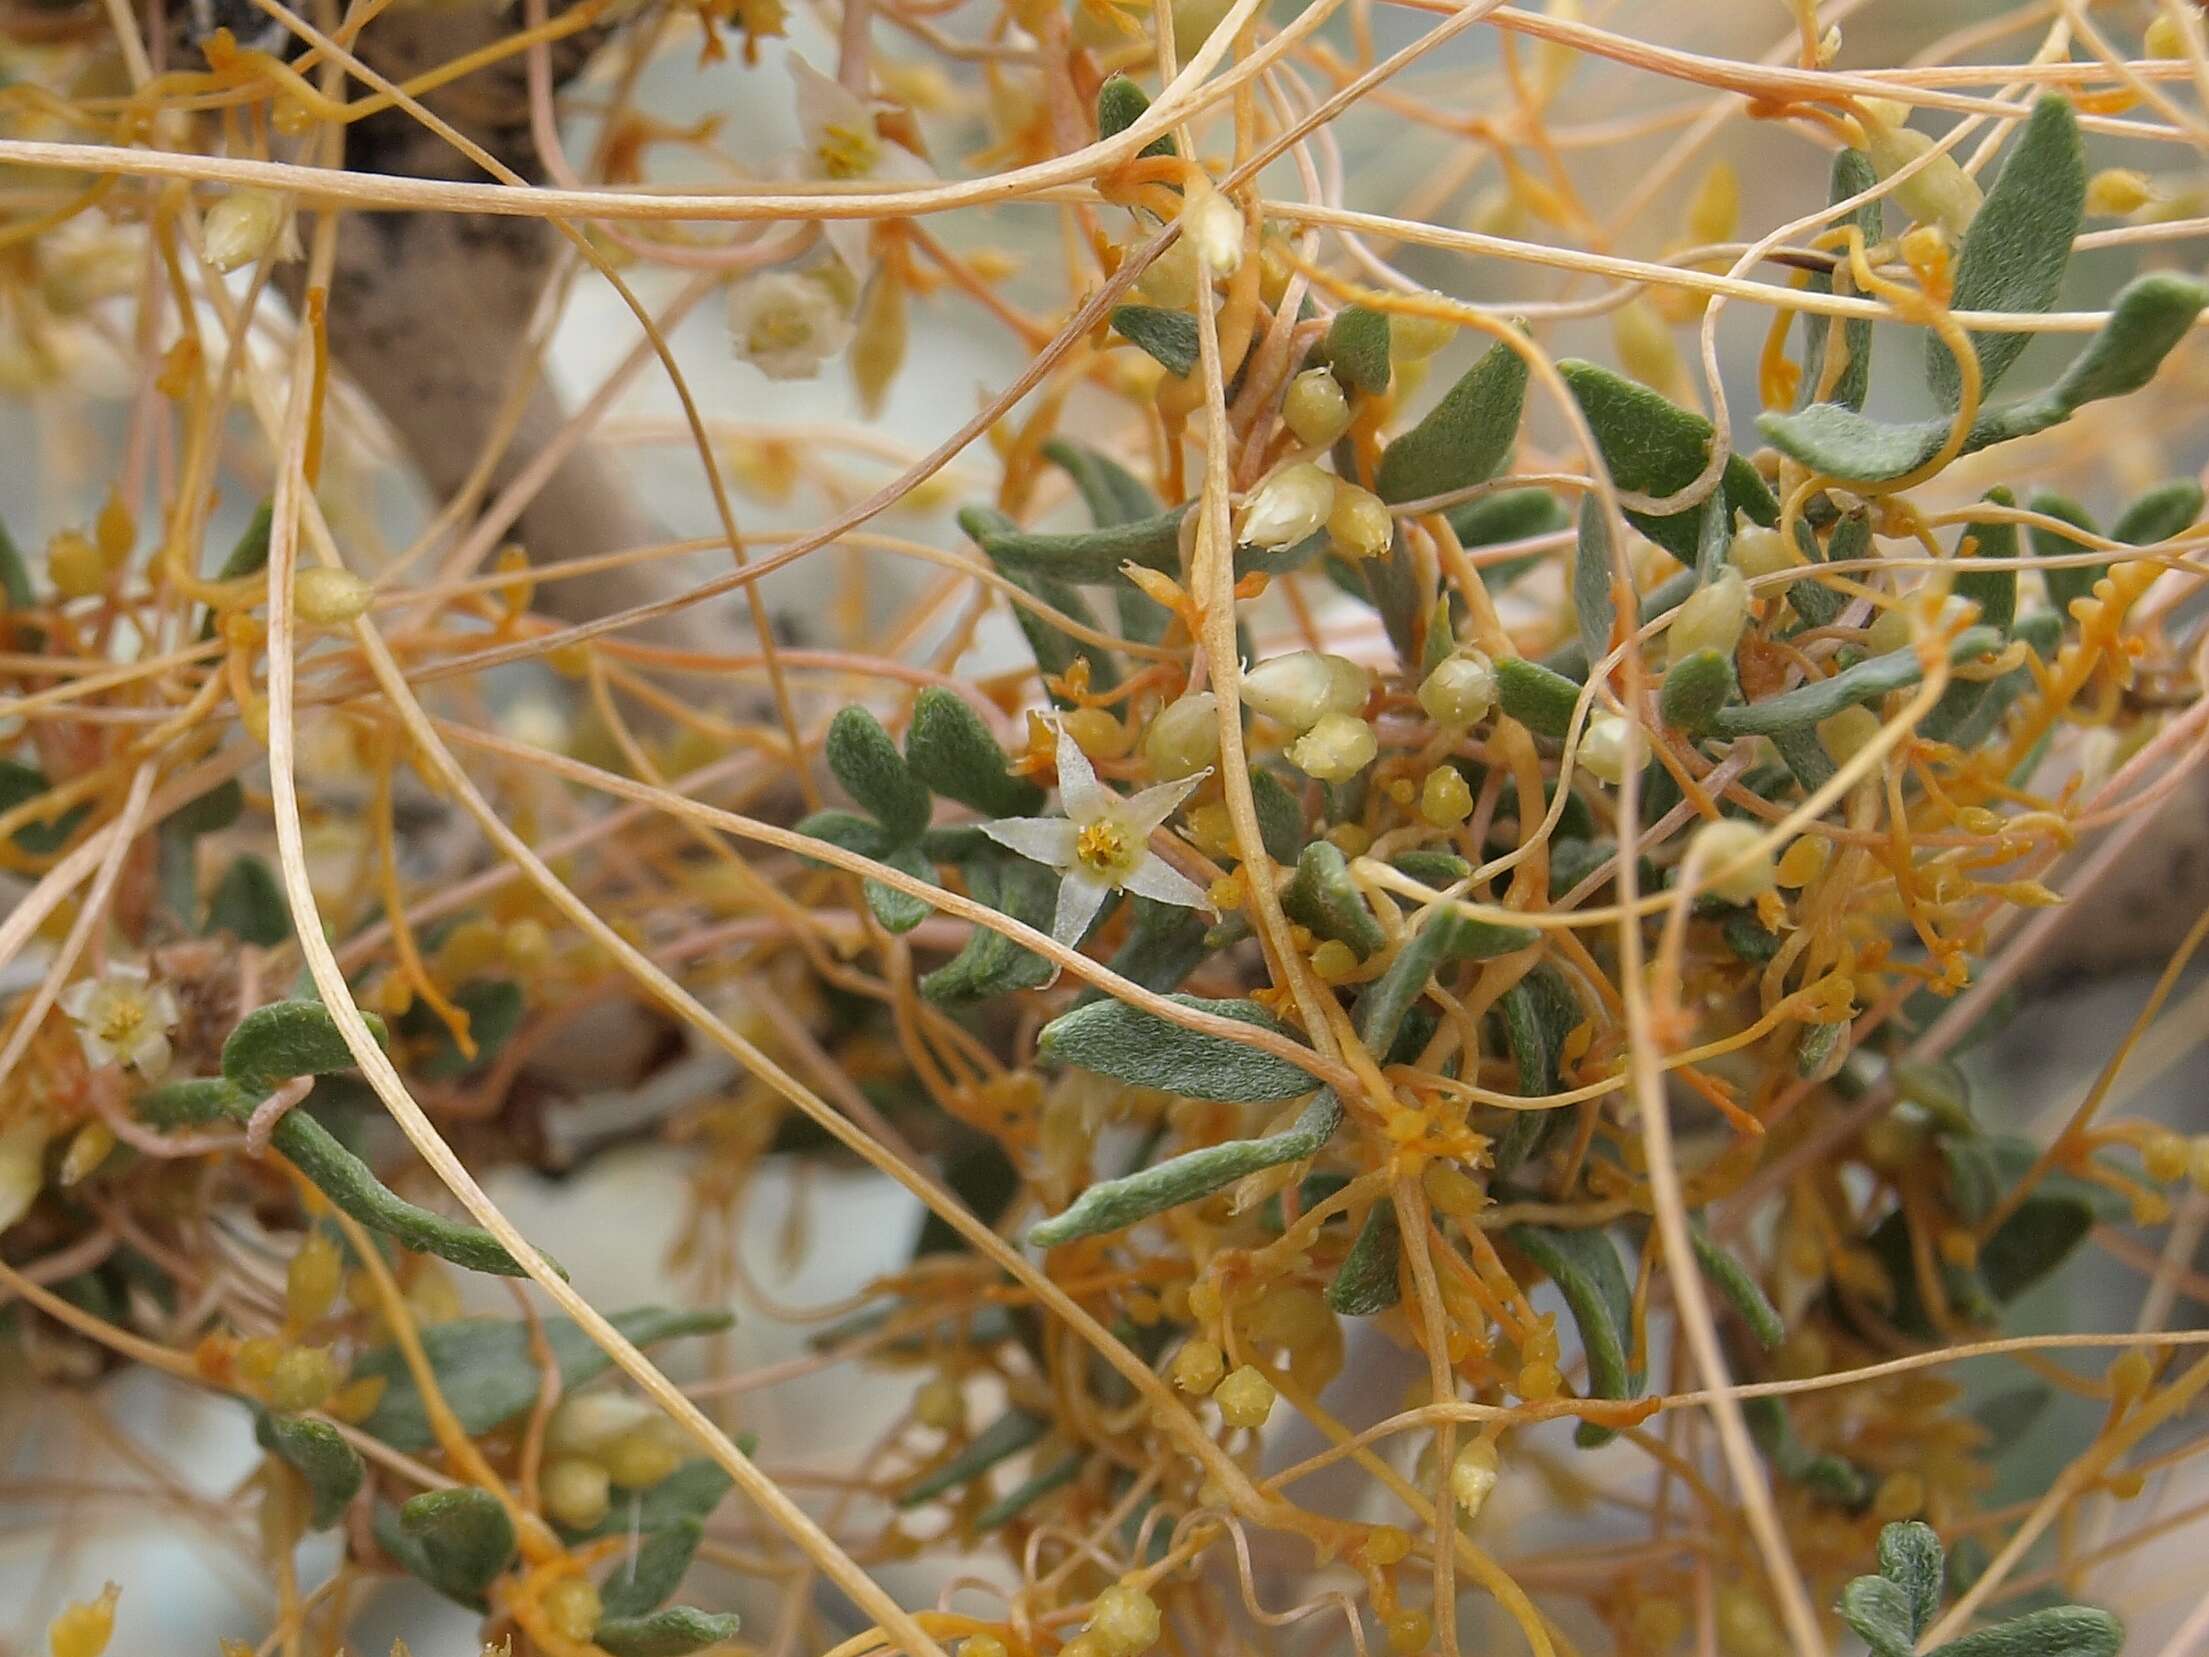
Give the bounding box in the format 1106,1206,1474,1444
1926,97,2085,409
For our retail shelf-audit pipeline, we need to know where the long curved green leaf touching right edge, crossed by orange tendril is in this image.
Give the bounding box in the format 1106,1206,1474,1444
1756,272,2209,484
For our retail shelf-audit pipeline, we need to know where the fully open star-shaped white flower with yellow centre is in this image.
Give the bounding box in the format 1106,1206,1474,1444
981,725,1211,950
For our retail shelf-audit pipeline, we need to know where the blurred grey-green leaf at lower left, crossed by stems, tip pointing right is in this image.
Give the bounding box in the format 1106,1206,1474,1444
353,1306,736,1449
